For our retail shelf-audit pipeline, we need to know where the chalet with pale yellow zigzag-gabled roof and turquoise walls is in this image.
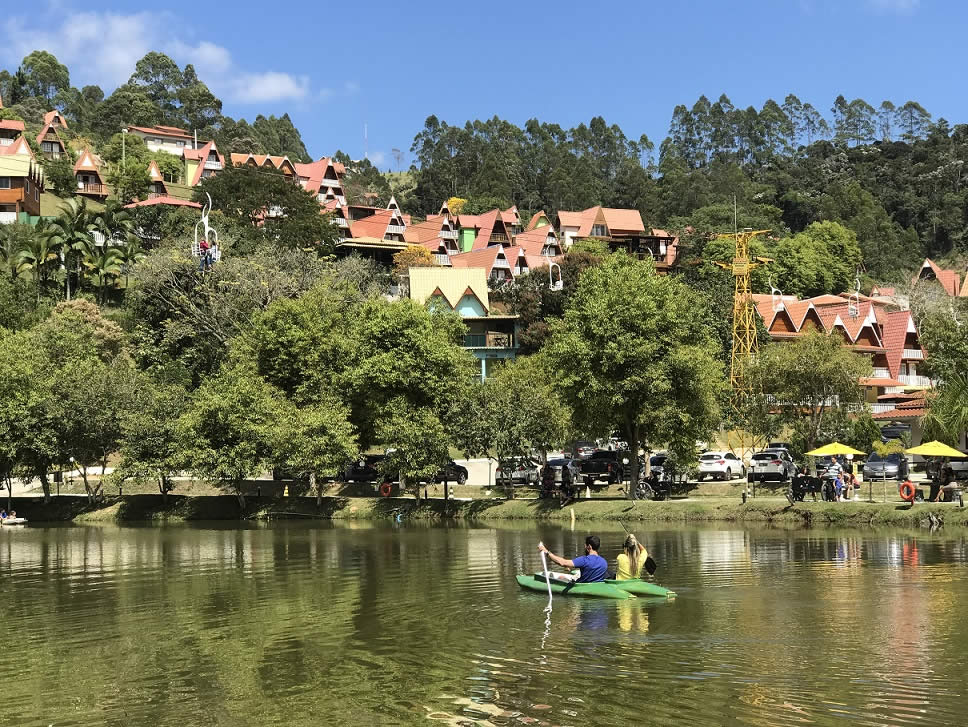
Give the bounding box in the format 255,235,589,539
409,268,518,381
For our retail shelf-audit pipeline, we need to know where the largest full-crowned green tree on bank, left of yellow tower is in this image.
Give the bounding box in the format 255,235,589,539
545,254,724,497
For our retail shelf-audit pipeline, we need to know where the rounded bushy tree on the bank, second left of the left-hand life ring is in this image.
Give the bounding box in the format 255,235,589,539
176,366,287,510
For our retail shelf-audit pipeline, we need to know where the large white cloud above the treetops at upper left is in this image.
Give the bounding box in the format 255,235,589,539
0,5,314,104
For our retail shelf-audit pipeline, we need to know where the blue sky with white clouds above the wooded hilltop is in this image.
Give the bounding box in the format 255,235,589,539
0,0,968,170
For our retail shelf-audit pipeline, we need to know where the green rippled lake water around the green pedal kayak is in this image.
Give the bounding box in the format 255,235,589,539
0,523,968,727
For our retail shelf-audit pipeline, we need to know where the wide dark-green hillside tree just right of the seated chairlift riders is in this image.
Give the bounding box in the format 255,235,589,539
194,166,339,255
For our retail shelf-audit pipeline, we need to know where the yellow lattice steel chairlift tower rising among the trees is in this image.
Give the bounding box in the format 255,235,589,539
716,227,773,472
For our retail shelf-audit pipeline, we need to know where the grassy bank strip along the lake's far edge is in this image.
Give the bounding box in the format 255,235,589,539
1,495,968,528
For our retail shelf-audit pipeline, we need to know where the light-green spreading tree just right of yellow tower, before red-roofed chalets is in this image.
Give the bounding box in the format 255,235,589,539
750,333,871,458
